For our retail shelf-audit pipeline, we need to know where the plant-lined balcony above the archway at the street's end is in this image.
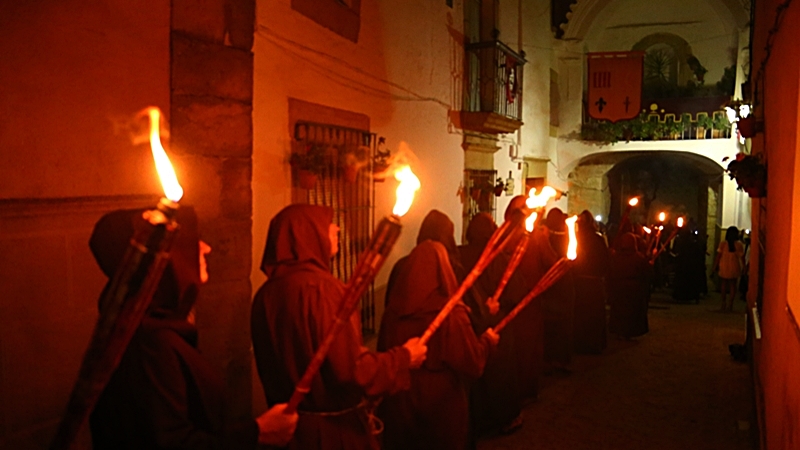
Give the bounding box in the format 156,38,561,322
581,97,731,143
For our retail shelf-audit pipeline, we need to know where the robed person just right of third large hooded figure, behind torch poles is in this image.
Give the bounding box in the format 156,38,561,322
459,213,522,436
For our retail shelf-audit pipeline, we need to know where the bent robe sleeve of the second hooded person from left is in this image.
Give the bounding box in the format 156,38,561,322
309,285,411,397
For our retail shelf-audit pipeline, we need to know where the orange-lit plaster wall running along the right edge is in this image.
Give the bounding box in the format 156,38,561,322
748,0,800,450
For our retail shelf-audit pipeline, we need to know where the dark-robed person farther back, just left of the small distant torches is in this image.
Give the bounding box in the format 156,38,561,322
608,233,652,339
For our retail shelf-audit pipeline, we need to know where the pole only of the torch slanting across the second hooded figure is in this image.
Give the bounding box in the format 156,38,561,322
285,215,402,414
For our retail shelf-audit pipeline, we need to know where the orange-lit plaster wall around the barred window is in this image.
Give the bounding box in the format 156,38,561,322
251,0,464,289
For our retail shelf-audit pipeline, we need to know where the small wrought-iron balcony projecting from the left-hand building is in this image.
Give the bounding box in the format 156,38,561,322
461,41,526,134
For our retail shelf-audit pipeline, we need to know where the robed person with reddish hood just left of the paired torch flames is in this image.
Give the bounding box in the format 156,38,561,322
500,195,558,398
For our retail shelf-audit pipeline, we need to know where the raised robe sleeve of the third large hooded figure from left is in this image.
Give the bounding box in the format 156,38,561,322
437,304,491,380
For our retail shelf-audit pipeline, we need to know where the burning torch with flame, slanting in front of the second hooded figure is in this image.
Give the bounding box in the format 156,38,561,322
285,166,420,414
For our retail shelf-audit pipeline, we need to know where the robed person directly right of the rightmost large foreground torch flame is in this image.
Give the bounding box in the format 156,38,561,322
572,211,611,354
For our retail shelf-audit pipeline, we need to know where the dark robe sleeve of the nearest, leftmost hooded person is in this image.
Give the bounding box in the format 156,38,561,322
141,330,258,449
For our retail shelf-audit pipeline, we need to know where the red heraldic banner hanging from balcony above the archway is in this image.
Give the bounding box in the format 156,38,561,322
586,52,644,122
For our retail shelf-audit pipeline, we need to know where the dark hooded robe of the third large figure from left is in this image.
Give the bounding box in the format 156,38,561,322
378,240,490,450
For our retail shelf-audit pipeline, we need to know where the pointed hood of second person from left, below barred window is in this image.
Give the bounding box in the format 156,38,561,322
261,205,333,277
